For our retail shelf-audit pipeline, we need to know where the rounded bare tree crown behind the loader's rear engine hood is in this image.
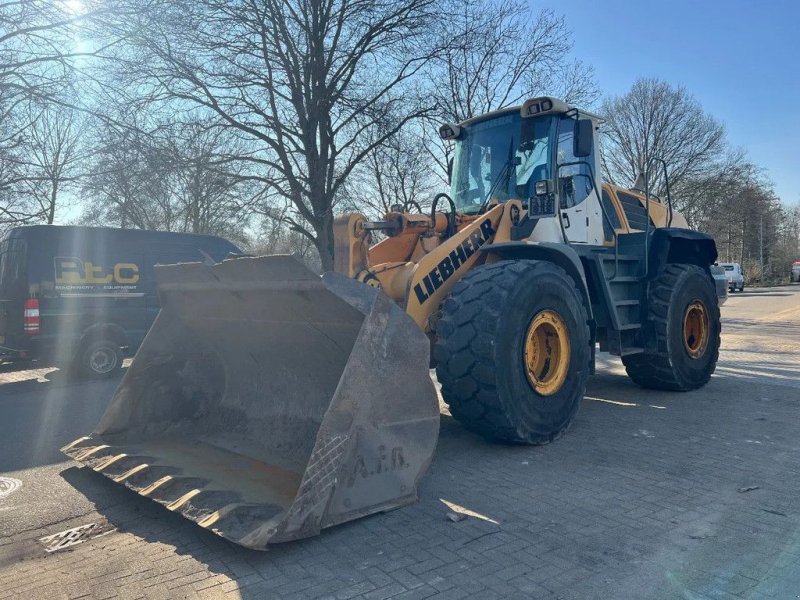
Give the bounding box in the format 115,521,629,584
602,79,727,193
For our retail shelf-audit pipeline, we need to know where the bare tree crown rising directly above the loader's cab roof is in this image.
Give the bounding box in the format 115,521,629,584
421,0,599,180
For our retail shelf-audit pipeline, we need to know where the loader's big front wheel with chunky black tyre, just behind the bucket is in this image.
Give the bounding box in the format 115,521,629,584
434,260,591,444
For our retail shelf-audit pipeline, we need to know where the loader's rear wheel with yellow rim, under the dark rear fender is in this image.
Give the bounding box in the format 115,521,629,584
622,264,721,391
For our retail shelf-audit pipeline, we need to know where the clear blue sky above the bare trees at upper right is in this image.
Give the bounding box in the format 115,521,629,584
564,0,800,204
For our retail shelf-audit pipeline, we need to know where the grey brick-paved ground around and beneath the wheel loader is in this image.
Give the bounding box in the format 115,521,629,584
0,287,800,600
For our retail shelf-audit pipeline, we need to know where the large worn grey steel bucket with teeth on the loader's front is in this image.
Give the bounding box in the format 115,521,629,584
62,256,439,549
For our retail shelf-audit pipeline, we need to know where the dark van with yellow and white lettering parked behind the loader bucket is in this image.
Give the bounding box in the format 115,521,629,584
0,225,241,377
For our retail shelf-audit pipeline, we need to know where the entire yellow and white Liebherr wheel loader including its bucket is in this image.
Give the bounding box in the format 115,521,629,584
63,97,720,549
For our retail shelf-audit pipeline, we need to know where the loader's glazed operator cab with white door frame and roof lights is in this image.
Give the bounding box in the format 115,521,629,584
439,97,604,244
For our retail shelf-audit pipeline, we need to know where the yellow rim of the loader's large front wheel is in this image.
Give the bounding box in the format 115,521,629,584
524,310,570,396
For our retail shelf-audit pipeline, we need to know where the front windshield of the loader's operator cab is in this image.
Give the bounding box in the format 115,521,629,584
451,111,554,214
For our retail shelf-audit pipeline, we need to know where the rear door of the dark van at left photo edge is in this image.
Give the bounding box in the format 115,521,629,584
0,230,28,354
